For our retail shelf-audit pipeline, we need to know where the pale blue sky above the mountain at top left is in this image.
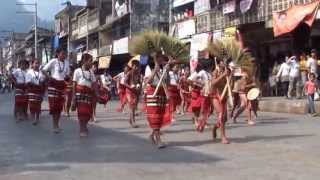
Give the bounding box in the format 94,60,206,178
18,0,86,20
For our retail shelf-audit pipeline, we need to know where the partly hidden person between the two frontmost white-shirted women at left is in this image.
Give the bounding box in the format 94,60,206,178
63,66,74,117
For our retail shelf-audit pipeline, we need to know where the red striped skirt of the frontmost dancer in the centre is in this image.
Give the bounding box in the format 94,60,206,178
145,86,172,129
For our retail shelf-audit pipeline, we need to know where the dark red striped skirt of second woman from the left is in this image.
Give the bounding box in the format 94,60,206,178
27,85,44,114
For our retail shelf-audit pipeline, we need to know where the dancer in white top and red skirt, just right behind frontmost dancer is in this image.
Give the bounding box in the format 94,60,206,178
168,64,181,121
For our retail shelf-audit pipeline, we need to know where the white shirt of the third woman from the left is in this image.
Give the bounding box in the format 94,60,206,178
43,58,70,81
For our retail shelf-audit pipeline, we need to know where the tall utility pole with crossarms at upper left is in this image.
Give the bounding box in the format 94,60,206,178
16,0,38,59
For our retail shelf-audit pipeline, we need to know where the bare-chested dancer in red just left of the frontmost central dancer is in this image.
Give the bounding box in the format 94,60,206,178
123,60,141,128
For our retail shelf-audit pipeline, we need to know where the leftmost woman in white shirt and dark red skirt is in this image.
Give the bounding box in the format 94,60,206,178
11,60,29,122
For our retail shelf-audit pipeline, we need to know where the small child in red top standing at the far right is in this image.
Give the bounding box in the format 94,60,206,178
304,73,319,116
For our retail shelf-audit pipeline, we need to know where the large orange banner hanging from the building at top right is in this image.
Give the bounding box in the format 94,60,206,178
273,1,320,37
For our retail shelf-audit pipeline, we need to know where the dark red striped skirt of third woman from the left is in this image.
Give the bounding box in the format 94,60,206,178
48,78,65,114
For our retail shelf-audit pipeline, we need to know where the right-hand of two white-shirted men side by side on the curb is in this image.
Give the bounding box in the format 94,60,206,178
288,56,301,99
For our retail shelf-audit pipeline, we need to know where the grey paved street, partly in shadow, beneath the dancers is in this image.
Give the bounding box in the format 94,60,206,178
0,95,320,180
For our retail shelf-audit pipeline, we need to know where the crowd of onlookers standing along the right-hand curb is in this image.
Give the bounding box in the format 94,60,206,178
269,49,320,114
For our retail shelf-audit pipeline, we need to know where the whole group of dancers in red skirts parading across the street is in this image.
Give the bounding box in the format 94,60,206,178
11,45,258,148
